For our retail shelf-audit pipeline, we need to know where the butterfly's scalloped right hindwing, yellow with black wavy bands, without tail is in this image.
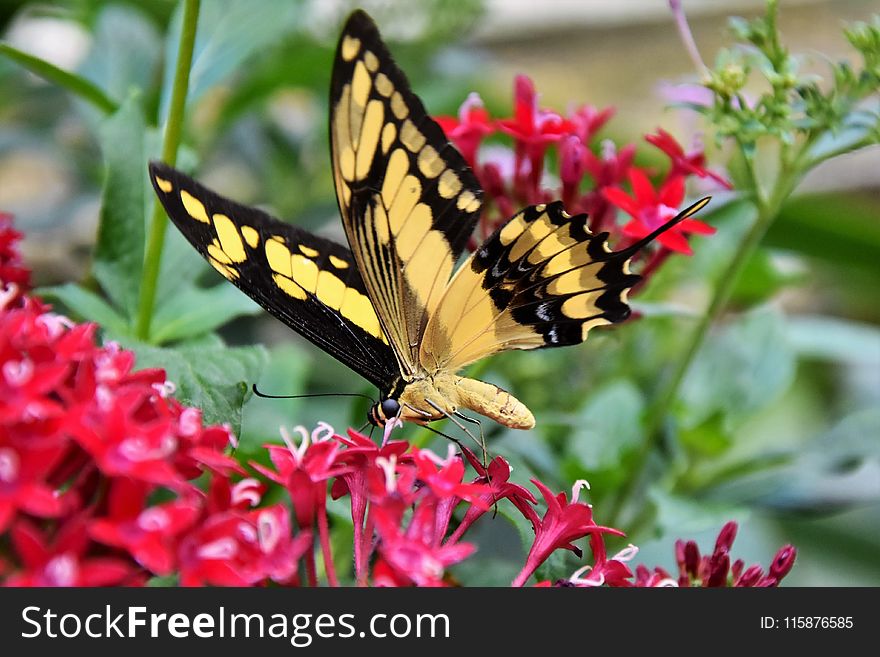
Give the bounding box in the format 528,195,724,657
420,201,639,371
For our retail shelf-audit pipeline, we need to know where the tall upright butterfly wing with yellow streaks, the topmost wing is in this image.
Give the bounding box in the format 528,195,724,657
330,11,482,376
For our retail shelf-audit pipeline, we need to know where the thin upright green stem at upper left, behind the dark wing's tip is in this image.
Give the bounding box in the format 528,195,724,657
135,0,199,340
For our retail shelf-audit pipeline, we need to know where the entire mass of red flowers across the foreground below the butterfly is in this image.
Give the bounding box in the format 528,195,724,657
0,218,795,586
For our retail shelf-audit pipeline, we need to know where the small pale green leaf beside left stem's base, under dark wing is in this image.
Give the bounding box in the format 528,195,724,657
152,283,262,343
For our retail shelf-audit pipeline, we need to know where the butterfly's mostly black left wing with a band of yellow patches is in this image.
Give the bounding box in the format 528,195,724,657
150,162,399,389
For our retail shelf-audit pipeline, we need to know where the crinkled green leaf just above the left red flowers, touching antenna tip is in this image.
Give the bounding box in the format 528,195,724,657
124,341,267,436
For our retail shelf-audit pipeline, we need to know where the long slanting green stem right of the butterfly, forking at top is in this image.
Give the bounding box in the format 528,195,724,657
608,140,800,527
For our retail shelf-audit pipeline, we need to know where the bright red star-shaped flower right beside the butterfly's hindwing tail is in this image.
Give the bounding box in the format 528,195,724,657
602,167,715,255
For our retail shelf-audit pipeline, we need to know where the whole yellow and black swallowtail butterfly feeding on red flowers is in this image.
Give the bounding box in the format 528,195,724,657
150,11,708,429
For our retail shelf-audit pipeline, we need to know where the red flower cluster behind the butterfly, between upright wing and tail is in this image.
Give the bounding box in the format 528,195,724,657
437,75,730,254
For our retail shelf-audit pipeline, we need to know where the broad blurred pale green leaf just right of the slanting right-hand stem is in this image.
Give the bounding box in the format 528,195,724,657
681,307,795,430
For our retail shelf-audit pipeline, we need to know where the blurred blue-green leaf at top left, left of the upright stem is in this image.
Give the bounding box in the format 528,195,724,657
80,4,162,98
